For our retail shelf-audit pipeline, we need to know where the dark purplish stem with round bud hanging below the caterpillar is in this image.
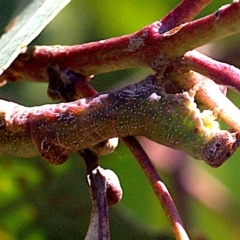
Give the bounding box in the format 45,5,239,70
82,153,122,240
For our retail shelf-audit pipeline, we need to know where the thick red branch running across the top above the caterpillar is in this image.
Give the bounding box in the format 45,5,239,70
0,1,240,84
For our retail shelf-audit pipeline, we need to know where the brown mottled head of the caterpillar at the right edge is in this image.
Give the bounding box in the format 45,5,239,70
202,131,240,167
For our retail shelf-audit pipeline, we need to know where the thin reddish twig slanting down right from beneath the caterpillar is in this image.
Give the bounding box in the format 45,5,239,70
123,137,189,240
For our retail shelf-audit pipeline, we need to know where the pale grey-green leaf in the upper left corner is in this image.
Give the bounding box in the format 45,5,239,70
0,0,70,74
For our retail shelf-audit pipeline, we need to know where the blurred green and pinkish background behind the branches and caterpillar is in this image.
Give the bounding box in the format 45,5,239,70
0,0,240,240
